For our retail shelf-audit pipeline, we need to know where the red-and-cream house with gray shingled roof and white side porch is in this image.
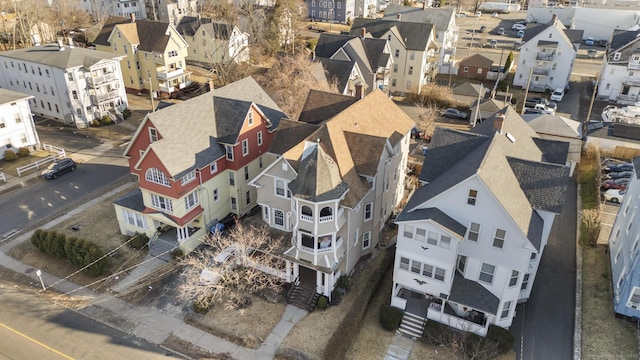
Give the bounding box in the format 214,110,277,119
114,77,285,253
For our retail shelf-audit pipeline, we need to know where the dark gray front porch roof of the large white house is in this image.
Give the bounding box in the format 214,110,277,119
448,272,500,315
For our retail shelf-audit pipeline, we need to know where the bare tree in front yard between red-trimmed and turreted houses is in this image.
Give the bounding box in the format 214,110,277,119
178,223,284,308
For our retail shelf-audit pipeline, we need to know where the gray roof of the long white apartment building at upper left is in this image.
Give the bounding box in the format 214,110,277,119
1,44,122,69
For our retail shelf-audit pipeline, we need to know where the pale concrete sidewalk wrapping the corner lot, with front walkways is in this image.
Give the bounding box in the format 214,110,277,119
0,173,307,360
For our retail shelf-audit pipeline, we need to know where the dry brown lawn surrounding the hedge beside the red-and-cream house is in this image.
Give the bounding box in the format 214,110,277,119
9,188,147,291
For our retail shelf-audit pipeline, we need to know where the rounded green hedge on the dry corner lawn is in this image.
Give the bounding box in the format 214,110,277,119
31,229,109,276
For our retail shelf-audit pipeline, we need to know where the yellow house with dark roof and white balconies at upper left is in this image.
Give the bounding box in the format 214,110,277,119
94,16,191,94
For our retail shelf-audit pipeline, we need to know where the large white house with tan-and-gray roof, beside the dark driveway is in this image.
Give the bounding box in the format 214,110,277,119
391,106,569,336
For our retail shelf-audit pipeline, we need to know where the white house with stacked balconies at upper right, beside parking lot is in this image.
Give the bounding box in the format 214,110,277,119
513,17,582,92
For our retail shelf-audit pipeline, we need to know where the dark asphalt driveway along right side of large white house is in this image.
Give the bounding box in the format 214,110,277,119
510,179,577,360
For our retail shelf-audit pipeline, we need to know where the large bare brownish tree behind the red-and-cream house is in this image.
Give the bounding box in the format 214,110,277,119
256,53,337,119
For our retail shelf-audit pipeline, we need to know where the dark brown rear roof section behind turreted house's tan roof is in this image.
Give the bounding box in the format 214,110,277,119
298,88,360,124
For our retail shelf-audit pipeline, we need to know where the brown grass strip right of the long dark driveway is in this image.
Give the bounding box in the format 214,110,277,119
578,150,638,359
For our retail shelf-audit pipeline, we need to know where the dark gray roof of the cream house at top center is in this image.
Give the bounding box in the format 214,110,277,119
349,18,435,51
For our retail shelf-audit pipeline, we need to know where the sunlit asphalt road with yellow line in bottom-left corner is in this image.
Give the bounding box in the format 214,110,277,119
0,287,171,360
